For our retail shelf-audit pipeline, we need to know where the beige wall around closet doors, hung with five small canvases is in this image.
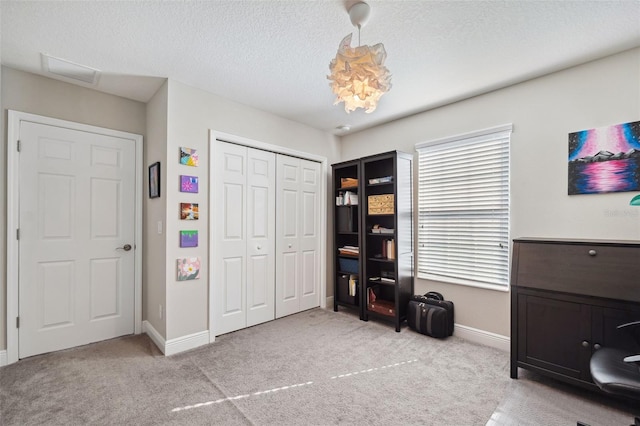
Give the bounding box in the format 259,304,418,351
166,80,339,339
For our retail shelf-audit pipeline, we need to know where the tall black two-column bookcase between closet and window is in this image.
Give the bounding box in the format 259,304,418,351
332,151,413,331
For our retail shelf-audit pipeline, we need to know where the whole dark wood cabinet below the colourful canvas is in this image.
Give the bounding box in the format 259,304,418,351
511,238,640,388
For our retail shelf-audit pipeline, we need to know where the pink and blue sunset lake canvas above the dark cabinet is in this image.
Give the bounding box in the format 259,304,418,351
568,121,640,195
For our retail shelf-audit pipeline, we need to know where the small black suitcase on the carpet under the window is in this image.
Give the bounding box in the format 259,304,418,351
407,291,453,337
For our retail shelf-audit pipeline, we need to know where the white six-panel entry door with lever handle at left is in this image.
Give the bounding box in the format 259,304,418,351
18,121,136,358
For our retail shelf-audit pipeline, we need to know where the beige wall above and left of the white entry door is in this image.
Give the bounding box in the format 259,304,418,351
0,67,146,349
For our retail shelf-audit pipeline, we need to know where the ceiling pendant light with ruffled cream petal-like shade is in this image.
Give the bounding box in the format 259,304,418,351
327,2,391,113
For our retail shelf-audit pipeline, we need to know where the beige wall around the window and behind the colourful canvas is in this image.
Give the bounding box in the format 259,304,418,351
342,49,640,336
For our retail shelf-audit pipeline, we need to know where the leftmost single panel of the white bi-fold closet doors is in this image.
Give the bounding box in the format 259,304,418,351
211,141,247,335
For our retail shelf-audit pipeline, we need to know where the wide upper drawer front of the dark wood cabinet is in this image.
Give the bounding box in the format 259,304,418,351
512,240,640,302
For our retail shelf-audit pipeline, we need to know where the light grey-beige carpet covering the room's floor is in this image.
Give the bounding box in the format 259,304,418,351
0,309,631,426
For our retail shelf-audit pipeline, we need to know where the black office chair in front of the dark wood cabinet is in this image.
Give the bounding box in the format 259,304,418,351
589,321,640,426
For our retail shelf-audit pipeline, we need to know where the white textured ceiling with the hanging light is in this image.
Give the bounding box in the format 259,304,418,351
0,0,640,133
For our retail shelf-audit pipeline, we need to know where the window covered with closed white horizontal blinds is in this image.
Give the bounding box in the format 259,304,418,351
416,124,512,290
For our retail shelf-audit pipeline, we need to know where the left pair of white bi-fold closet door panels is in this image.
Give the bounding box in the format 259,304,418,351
211,141,276,335
